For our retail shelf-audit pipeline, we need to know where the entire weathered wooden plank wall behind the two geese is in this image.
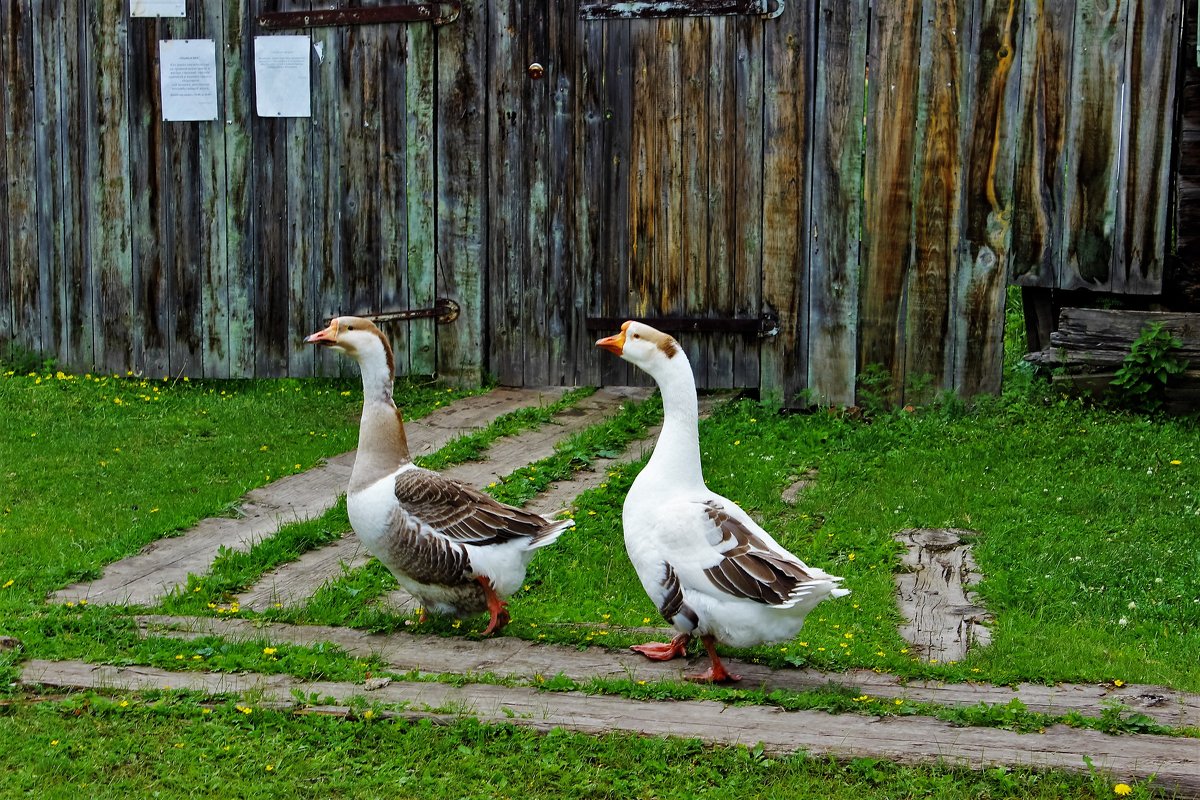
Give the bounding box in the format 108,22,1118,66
0,0,1181,403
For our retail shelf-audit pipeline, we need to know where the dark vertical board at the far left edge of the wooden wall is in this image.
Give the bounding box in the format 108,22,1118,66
0,0,41,355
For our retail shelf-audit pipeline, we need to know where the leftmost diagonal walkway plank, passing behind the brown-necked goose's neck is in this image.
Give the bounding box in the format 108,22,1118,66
50,389,565,606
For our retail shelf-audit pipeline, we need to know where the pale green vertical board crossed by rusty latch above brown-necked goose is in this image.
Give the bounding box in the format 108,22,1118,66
404,25,437,375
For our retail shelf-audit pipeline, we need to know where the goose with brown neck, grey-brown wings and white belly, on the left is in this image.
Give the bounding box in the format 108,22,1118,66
305,317,575,636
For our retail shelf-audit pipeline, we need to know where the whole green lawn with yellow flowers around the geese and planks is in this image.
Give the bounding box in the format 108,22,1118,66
0,340,1200,798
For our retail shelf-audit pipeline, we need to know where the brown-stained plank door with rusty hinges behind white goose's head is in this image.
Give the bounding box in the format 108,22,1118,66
487,0,805,387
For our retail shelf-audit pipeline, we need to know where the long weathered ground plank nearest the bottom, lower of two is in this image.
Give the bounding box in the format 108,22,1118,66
22,661,1200,796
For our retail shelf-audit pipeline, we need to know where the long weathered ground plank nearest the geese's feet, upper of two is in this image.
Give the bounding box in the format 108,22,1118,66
137,615,1200,744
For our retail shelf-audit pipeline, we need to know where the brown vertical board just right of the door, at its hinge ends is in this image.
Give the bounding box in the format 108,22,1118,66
761,4,814,405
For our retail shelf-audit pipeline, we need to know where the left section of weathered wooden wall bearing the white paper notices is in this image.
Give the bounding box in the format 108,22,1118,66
0,0,485,383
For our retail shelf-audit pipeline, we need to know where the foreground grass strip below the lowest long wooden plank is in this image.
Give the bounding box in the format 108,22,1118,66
0,692,1166,800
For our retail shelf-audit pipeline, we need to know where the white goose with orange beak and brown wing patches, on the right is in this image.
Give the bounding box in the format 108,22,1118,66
596,321,850,681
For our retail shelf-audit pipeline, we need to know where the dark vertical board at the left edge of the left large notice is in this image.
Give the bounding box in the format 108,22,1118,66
122,18,170,377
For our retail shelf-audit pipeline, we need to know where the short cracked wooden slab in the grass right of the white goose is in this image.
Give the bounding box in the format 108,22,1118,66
895,528,991,662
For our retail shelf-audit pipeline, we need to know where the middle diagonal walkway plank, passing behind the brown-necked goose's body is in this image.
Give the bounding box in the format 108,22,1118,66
238,387,650,610
